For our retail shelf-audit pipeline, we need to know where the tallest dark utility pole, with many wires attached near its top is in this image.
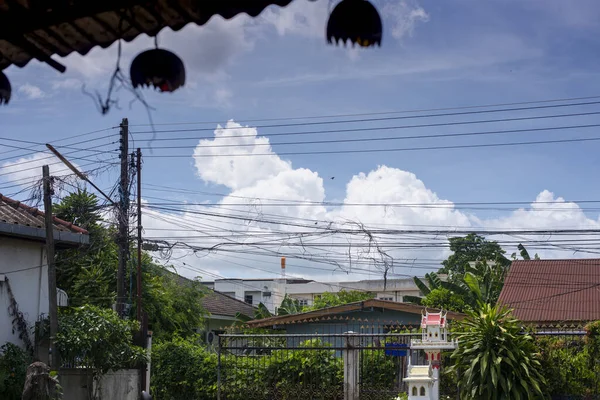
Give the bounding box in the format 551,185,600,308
117,118,129,317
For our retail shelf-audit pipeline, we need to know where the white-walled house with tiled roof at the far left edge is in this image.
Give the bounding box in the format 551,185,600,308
0,194,89,347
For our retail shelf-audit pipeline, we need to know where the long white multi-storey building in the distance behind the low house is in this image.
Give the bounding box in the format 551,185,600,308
205,278,420,313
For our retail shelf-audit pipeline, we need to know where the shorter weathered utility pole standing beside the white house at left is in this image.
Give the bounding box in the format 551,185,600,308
42,165,60,371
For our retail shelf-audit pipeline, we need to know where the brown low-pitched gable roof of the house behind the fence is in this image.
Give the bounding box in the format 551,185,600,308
247,299,464,328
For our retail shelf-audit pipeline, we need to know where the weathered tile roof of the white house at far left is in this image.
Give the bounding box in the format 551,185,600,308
0,194,88,235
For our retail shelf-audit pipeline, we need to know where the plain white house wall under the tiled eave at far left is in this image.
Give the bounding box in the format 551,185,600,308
0,236,48,346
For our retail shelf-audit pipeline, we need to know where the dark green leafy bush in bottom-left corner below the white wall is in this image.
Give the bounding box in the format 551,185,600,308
0,343,31,400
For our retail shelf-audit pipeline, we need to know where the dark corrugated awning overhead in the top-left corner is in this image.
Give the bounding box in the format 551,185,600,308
0,0,292,71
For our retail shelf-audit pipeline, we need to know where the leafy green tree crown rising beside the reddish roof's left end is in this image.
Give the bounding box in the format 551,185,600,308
438,233,510,283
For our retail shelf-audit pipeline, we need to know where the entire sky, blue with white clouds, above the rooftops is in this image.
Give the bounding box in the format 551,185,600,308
0,0,600,281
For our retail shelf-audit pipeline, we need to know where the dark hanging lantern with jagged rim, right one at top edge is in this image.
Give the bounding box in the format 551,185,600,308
327,0,383,47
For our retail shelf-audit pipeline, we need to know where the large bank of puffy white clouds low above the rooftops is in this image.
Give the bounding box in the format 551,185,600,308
138,121,600,280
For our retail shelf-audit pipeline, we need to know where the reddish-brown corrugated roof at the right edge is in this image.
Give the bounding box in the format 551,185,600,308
498,258,600,323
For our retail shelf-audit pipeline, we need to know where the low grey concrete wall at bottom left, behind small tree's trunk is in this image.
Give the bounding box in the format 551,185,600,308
59,368,141,400
